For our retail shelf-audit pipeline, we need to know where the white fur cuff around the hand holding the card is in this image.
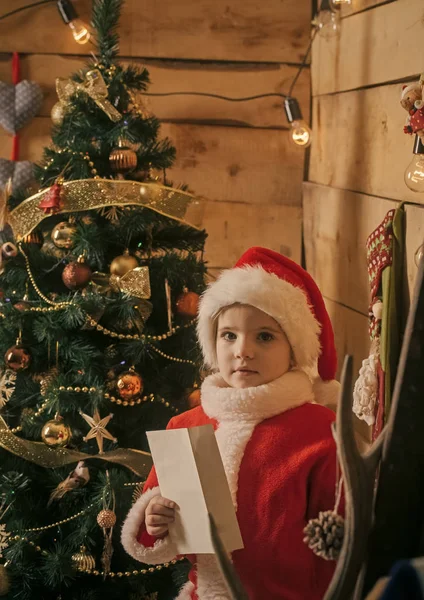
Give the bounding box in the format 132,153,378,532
121,487,177,565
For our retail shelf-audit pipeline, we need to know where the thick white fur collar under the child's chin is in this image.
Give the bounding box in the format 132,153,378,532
201,370,314,423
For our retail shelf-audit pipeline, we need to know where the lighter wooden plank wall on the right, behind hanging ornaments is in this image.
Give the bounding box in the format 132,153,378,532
304,0,424,436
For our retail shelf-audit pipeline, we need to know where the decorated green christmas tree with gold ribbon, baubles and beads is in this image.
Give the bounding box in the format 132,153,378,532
0,0,206,600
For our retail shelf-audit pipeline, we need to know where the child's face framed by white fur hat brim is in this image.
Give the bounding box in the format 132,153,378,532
216,305,291,388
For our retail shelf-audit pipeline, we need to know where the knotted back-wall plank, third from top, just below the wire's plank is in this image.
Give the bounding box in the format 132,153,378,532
0,117,304,206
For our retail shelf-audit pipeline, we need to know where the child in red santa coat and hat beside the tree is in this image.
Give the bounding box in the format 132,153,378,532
122,248,338,600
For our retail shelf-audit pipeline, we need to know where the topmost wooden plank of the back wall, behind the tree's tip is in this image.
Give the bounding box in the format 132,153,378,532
0,0,311,63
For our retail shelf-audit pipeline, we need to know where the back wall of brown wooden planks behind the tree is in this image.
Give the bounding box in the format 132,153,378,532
0,0,312,274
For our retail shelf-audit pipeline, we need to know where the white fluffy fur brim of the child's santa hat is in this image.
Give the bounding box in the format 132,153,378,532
197,265,321,369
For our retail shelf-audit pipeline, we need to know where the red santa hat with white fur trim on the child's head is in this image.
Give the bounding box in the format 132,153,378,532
197,247,339,406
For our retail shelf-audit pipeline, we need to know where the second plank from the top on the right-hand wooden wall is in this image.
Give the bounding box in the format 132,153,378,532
309,84,424,204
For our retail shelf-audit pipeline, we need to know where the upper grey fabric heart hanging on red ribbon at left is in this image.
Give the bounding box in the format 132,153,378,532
0,80,43,134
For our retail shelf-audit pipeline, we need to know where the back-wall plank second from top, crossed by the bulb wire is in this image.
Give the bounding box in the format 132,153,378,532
0,54,310,128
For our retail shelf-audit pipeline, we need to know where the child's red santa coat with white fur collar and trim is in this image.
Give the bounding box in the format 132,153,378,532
122,371,336,600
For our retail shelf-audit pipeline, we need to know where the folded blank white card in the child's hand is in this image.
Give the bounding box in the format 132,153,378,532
147,425,243,554
